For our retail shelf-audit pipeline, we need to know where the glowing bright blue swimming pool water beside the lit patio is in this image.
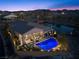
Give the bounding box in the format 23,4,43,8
36,38,58,51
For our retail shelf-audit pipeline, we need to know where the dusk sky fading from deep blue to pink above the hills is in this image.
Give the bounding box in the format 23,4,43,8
0,0,79,11
